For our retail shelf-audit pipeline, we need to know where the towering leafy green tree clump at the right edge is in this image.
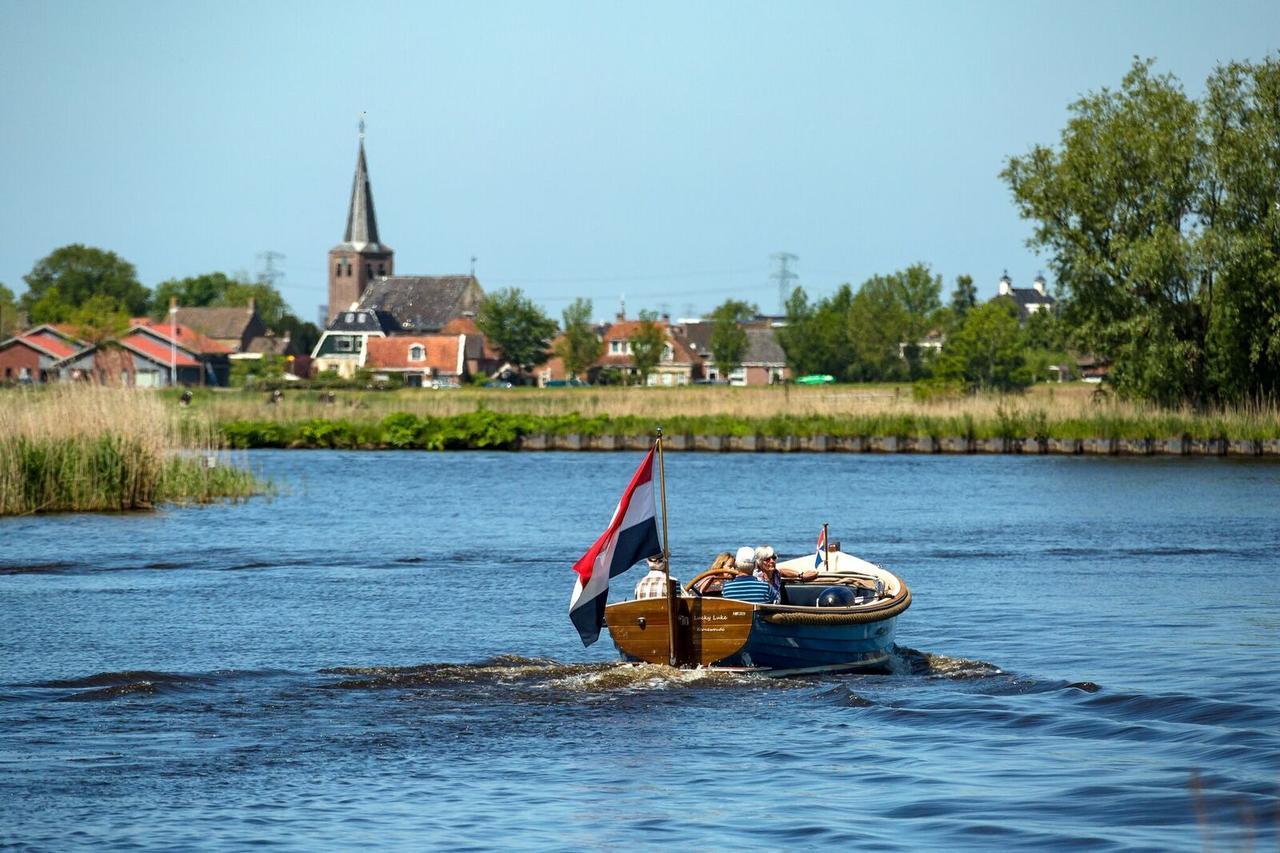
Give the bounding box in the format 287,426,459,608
1001,58,1280,405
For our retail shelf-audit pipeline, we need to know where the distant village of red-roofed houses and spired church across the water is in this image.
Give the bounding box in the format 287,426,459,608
0,134,1070,388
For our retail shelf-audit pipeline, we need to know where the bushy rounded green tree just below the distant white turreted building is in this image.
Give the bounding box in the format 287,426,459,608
934,300,1032,391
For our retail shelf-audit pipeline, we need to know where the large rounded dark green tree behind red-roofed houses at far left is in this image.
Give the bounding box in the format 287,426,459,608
19,243,148,325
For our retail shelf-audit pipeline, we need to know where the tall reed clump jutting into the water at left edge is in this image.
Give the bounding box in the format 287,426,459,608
0,386,261,516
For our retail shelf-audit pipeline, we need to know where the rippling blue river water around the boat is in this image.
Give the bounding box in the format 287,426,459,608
0,451,1280,850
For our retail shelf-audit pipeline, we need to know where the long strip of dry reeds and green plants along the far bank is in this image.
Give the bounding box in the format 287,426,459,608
177,383,1280,447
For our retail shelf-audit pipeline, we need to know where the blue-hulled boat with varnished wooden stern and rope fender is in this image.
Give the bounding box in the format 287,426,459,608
604,551,911,675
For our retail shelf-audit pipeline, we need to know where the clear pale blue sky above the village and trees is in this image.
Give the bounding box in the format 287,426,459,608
0,0,1280,319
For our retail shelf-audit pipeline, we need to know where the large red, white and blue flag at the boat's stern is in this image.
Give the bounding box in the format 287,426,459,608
568,450,662,646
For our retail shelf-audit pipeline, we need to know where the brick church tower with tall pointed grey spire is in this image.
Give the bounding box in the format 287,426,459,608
328,115,396,320
